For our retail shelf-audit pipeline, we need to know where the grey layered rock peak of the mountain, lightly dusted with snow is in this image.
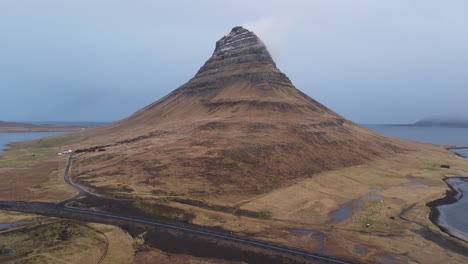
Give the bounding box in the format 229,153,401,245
197,26,276,76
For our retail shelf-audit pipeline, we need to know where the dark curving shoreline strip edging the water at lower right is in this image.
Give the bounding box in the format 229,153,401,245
426,176,468,242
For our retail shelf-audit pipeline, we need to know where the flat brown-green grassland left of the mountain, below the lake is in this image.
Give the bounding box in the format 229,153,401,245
0,133,87,202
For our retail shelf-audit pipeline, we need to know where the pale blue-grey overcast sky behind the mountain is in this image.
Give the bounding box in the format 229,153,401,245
0,0,468,123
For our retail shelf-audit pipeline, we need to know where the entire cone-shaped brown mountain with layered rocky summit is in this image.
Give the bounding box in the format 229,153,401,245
74,27,412,198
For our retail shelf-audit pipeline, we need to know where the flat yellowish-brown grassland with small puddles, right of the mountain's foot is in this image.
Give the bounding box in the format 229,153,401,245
111,147,468,264
